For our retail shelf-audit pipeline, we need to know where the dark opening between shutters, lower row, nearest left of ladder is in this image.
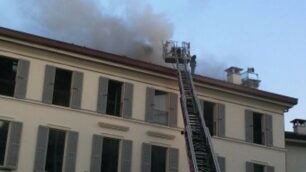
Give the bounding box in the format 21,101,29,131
151,146,167,172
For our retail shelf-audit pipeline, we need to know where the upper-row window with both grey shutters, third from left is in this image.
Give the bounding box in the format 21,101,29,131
97,77,133,118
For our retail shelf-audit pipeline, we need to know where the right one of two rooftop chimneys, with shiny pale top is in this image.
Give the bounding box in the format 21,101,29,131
241,67,260,88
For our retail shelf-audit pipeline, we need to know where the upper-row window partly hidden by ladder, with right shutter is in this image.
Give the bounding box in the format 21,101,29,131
200,100,225,137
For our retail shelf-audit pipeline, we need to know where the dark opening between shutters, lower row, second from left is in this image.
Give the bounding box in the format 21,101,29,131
45,129,65,172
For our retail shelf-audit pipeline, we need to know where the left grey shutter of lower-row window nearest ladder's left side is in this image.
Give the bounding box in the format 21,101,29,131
141,143,152,172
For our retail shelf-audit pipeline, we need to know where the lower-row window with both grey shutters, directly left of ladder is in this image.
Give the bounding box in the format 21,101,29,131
141,143,179,172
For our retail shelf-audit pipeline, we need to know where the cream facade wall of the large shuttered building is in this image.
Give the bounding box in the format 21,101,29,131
0,38,285,172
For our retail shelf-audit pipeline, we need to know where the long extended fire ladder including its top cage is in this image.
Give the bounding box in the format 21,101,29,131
163,41,220,172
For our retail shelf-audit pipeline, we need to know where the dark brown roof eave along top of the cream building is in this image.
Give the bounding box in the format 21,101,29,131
0,27,298,108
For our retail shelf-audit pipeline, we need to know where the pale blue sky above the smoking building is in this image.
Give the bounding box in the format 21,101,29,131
0,0,306,131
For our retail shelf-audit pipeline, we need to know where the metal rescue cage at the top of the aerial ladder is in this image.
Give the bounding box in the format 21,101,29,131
163,41,191,63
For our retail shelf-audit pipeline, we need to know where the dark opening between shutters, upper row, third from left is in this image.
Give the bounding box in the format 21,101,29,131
106,80,123,116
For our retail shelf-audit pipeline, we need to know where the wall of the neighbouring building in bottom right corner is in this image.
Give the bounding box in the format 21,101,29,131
286,143,306,172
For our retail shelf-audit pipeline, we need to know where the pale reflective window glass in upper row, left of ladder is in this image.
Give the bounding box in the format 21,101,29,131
152,90,169,125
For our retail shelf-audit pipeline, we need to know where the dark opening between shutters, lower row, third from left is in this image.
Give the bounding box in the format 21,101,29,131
101,138,120,172
